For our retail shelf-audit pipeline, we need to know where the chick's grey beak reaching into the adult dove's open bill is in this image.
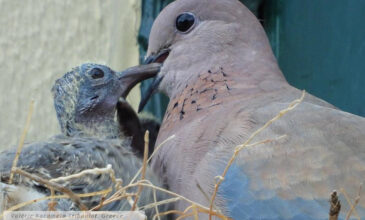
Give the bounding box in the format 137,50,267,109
117,63,161,98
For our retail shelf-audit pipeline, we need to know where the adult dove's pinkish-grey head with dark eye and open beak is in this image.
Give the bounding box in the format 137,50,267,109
141,0,282,111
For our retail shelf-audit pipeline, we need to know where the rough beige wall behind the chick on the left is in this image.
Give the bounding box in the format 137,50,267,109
0,0,140,149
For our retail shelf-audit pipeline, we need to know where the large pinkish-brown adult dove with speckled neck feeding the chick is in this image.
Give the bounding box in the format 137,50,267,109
137,0,365,220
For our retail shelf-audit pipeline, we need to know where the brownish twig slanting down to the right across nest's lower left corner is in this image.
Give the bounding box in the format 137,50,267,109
12,167,87,211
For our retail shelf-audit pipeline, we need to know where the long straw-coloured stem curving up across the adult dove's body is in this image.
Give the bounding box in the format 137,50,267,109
209,91,305,220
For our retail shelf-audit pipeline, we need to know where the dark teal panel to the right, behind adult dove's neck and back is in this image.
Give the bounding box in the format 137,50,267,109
265,0,365,116
